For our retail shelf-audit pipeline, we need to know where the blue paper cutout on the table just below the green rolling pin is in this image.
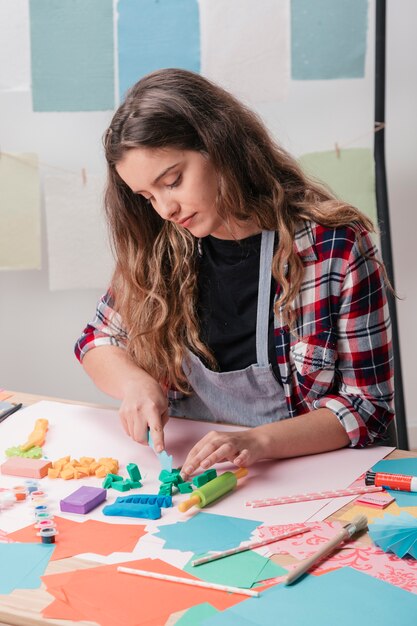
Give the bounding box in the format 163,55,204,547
155,512,262,554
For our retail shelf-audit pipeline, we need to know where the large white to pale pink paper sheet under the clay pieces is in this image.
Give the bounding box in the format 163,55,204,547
0,401,391,541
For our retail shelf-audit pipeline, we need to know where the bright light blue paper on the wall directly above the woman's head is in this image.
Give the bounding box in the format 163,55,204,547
118,0,200,100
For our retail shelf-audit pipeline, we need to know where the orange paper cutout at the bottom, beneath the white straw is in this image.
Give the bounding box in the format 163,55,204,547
42,559,245,626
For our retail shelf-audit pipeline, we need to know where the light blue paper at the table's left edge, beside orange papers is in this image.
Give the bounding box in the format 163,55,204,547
0,542,55,594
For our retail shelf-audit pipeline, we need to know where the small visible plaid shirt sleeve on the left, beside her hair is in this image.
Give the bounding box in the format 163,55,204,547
74,291,127,363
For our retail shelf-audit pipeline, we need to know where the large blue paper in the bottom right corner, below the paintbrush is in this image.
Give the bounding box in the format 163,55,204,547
201,567,417,626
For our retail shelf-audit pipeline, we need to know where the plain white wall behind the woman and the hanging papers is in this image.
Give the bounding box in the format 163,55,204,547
0,0,417,438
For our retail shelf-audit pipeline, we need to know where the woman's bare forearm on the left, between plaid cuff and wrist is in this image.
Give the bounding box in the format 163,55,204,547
82,346,154,400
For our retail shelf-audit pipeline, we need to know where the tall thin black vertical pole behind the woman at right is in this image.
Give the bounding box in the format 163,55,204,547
374,0,408,450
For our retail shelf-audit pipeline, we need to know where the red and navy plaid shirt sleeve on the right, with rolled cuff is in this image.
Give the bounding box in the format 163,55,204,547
314,232,394,447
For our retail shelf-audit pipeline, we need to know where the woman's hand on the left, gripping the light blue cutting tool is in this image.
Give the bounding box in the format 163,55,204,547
119,374,168,452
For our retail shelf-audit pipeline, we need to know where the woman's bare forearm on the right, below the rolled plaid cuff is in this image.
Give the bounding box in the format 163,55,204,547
254,409,350,459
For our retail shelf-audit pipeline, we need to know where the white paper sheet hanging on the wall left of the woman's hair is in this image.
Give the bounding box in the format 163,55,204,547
44,172,113,290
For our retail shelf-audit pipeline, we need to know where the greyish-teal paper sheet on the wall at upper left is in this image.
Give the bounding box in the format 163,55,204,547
29,0,114,111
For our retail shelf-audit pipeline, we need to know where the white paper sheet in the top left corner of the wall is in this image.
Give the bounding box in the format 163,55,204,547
0,0,30,91
